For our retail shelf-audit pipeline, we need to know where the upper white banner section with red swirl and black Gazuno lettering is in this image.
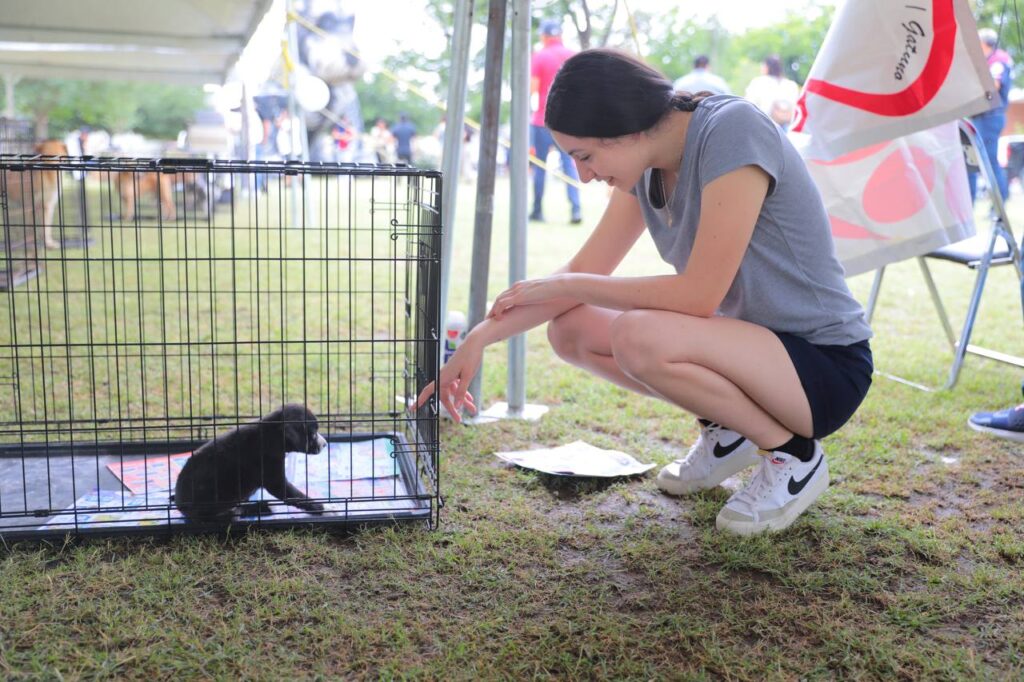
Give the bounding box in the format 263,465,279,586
793,0,997,159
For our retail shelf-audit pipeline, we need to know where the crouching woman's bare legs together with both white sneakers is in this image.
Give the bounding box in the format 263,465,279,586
548,306,828,535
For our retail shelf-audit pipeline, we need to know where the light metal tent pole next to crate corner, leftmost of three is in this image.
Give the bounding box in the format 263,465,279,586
437,0,473,357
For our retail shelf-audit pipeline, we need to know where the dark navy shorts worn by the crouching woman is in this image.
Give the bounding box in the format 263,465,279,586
775,332,874,438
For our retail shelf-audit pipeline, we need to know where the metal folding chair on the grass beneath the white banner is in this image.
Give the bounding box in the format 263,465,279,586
867,119,1024,390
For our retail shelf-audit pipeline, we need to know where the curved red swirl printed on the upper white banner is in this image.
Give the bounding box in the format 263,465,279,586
793,0,956,132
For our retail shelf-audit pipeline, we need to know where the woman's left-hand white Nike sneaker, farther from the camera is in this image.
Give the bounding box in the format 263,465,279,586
656,423,761,495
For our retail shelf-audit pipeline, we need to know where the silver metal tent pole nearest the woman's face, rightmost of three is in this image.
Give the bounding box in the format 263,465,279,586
507,0,529,414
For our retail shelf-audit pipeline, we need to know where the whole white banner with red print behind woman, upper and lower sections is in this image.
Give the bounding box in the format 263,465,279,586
791,0,997,275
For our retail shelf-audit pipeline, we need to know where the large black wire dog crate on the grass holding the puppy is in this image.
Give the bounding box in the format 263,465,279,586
0,156,441,537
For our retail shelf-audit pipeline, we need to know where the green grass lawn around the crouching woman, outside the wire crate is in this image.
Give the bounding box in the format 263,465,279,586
0,174,1024,680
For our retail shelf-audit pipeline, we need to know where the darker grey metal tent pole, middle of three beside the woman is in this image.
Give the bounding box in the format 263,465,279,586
469,0,508,399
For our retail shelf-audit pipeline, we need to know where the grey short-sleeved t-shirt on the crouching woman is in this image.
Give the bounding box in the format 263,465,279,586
633,95,871,345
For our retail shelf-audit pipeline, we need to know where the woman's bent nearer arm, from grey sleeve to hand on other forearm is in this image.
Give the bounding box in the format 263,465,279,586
490,166,768,319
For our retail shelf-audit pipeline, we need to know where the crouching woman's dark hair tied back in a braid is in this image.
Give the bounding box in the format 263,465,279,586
544,48,711,138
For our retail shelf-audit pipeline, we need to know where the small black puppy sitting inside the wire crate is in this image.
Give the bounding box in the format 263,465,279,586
174,404,327,522
